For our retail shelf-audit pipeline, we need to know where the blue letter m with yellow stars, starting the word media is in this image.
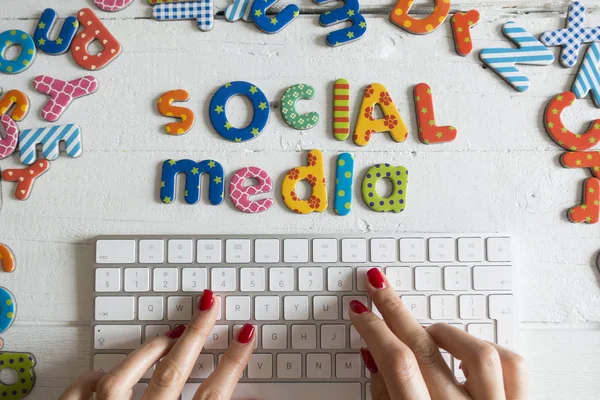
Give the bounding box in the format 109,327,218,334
160,160,225,206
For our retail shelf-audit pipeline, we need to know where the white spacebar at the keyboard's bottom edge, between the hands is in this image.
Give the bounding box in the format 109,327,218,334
181,383,362,400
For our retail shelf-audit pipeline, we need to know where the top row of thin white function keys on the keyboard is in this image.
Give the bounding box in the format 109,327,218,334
96,237,512,264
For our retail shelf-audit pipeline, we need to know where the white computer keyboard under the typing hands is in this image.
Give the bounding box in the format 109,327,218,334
92,234,516,400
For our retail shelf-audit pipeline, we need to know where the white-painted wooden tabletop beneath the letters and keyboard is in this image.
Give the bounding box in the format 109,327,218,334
0,0,600,400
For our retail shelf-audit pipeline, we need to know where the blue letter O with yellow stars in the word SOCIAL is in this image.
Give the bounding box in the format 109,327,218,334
208,81,271,142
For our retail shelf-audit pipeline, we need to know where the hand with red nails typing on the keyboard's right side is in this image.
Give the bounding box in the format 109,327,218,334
350,268,527,400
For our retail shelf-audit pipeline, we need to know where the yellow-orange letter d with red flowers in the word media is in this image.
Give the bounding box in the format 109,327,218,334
281,150,327,214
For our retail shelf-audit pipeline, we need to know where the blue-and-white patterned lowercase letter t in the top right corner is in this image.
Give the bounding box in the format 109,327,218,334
540,1,600,67
